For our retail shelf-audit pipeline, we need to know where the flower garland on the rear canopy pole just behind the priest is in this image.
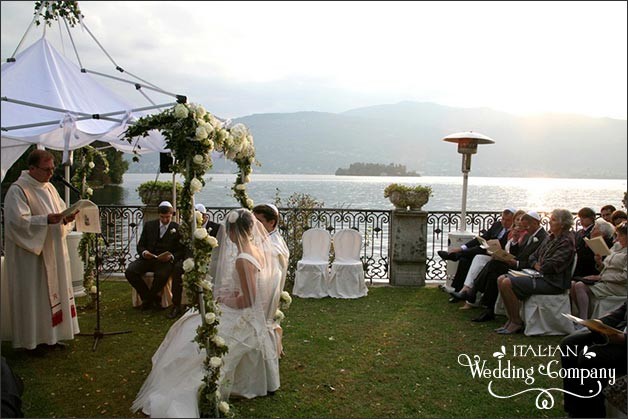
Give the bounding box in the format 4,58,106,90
70,145,109,299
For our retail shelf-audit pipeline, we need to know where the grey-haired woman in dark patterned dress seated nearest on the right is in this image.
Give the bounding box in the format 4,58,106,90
497,209,576,335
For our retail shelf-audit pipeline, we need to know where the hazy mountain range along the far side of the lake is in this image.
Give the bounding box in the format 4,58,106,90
127,102,627,179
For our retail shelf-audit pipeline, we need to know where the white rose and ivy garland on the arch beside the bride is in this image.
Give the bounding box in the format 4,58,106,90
124,103,257,417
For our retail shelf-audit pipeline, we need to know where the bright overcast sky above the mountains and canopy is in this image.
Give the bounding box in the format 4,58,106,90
1,1,628,119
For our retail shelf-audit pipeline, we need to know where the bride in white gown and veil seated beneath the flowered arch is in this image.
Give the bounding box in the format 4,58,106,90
131,209,281,417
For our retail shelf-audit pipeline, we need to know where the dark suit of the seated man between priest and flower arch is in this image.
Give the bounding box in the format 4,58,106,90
124,220,185,306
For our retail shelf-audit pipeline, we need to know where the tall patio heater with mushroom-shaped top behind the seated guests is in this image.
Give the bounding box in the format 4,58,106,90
443,131,495,286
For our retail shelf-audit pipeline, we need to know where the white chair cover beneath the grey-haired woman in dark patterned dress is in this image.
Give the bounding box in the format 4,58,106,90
522,290,575,336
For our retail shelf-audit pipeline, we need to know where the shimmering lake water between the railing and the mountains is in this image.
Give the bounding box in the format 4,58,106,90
93,173,627,212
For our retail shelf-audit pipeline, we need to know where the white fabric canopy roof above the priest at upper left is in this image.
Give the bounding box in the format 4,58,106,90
1,37,171,178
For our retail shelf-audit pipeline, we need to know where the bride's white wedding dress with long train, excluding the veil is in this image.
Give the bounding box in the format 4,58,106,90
132,253,279,418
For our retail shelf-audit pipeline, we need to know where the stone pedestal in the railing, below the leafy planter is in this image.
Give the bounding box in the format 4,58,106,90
390,210,427,287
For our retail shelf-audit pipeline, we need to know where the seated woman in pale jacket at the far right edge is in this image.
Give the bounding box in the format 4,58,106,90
571,223,628,319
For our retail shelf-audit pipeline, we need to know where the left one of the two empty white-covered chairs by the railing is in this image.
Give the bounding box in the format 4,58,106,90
292,228,331,298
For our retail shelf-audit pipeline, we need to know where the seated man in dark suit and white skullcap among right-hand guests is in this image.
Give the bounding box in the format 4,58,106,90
472,211,547,322
